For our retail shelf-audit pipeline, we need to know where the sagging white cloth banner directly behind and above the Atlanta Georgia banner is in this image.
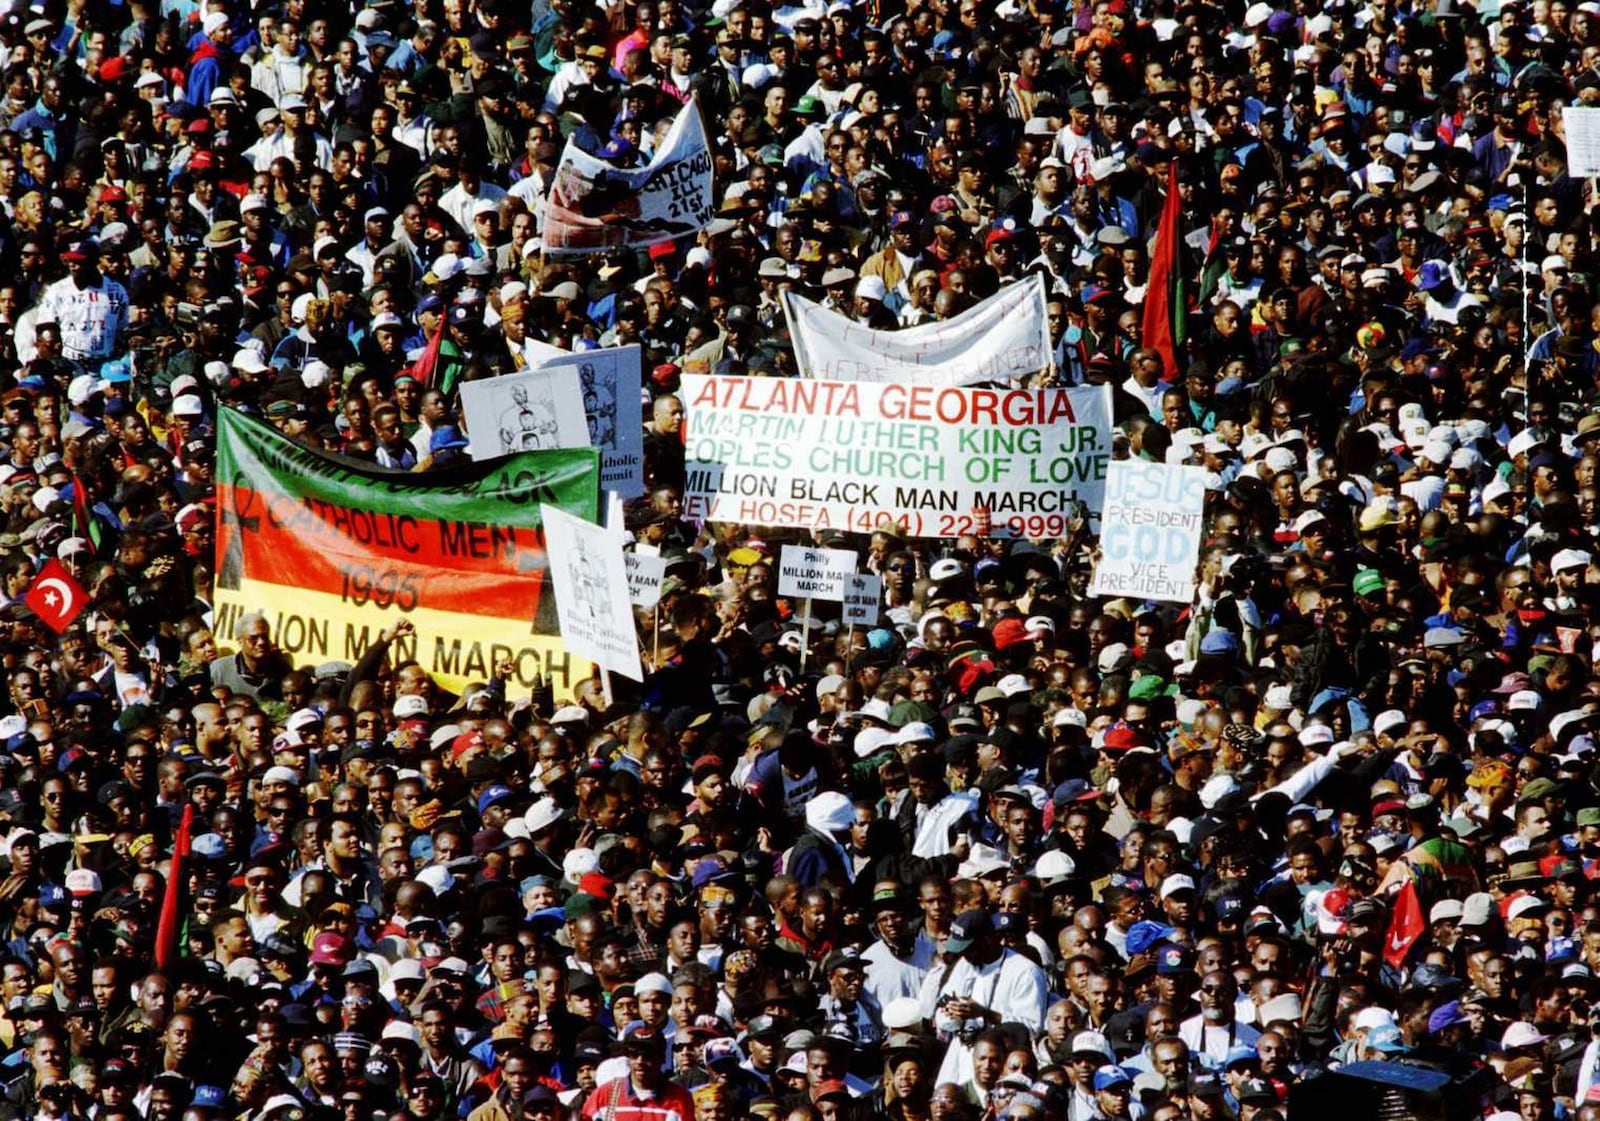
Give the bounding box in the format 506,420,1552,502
784,273,1051,385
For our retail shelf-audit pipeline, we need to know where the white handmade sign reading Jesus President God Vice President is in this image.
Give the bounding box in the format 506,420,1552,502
1090,459,1206,603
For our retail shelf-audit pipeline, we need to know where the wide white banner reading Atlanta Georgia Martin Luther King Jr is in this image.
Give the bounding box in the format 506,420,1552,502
682,374,1112,539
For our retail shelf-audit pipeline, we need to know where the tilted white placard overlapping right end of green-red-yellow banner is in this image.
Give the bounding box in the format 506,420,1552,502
539,504,645,681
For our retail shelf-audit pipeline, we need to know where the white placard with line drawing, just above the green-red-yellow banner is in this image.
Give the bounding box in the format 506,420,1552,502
461,366,589,459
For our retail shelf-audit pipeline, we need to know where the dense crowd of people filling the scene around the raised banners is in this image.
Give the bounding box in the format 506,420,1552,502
0,0,1600,1121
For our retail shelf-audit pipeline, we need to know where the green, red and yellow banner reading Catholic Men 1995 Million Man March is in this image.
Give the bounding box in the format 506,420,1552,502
214,409,600,696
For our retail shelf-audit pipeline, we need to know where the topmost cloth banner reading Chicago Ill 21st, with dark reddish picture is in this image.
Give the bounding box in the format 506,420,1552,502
542,101,715,256
